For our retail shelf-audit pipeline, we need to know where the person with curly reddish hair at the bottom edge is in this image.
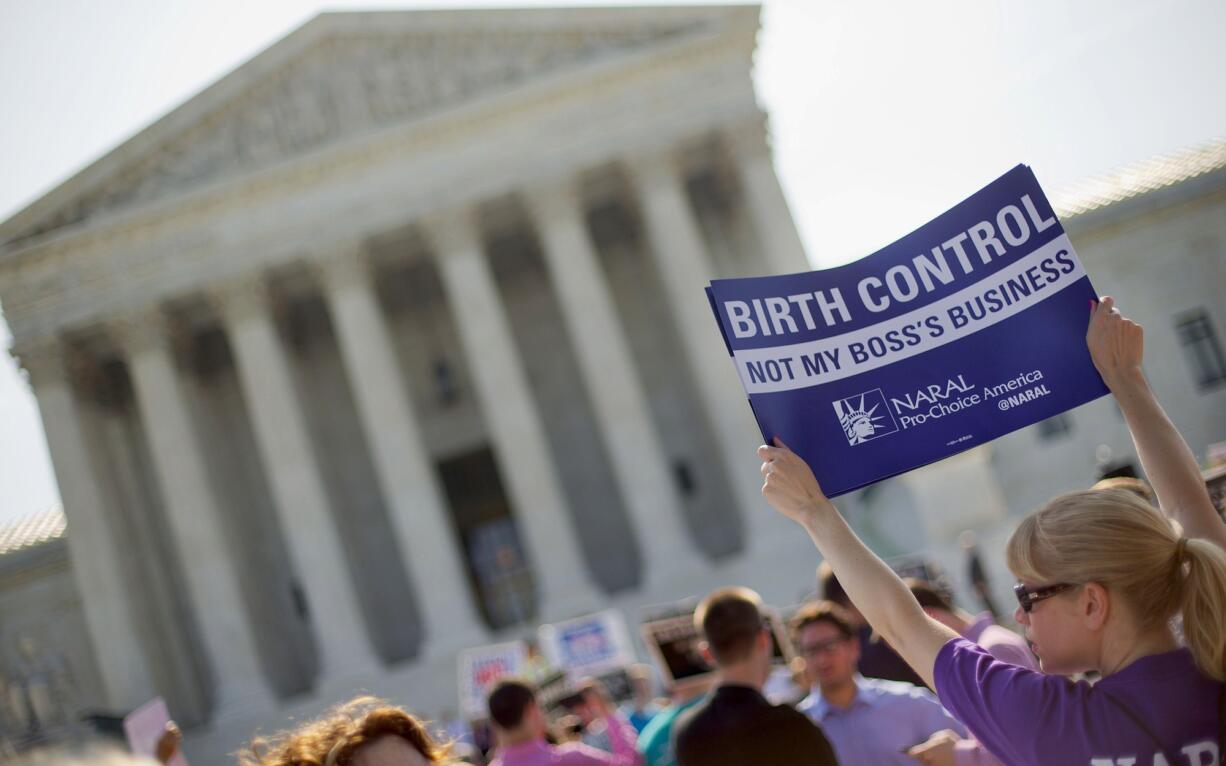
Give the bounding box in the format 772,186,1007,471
238,696,460,766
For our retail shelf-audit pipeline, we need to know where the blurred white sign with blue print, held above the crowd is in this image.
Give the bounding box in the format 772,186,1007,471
537,609,635,680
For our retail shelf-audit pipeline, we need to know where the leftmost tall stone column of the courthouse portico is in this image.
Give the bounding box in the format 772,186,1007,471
16,342,157,712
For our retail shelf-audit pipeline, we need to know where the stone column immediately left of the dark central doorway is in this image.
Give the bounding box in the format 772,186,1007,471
318,248,488,652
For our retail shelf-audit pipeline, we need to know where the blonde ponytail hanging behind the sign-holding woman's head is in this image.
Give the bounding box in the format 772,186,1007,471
1182,538,1226,681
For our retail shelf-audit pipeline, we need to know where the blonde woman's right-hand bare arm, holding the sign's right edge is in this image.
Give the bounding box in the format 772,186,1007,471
1086,297,1226,548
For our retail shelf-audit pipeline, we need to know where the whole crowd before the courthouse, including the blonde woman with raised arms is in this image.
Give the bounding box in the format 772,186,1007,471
14,298,1226,766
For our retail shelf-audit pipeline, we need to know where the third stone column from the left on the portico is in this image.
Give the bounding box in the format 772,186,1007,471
216,276,379,688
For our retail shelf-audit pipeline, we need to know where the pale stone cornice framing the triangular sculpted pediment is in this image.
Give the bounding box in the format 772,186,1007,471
0,5,759,251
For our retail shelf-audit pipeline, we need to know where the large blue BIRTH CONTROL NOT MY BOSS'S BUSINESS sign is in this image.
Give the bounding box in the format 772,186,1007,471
707,165,1107,496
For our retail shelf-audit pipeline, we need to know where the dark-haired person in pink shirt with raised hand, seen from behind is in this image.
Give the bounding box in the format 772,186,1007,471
488,679,642,766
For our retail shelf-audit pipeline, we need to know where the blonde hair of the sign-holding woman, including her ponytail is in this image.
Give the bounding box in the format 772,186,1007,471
1007,489,1226,680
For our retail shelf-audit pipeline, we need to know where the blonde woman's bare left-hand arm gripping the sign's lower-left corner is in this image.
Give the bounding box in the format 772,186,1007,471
758,438,958,689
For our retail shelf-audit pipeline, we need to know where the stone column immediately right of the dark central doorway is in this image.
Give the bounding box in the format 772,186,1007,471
428,212,598,619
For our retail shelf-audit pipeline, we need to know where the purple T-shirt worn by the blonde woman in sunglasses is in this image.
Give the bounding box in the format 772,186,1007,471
933,639,1221,766
